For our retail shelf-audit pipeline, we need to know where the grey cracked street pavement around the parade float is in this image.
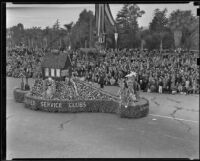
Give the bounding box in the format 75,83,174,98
6,78,199,160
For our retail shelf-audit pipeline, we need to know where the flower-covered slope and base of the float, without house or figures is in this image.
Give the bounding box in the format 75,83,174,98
25,75,149,118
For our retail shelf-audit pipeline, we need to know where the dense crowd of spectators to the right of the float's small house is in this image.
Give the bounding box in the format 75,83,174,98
72,50,199,94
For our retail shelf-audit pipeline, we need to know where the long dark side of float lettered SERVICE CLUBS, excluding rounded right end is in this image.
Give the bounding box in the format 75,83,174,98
24,94,119,113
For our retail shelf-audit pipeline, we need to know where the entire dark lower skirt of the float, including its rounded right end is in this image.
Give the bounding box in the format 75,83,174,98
24,93,149,118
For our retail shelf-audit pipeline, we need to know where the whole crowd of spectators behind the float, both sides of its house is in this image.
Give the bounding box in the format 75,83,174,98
7,48,199,94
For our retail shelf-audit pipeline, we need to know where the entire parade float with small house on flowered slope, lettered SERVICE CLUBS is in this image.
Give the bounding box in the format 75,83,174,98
11,49,149,118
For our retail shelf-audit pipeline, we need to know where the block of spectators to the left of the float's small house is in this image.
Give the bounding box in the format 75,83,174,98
6,47,45,78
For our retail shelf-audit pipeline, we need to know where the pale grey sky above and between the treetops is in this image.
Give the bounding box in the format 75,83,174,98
6,3,197,28
